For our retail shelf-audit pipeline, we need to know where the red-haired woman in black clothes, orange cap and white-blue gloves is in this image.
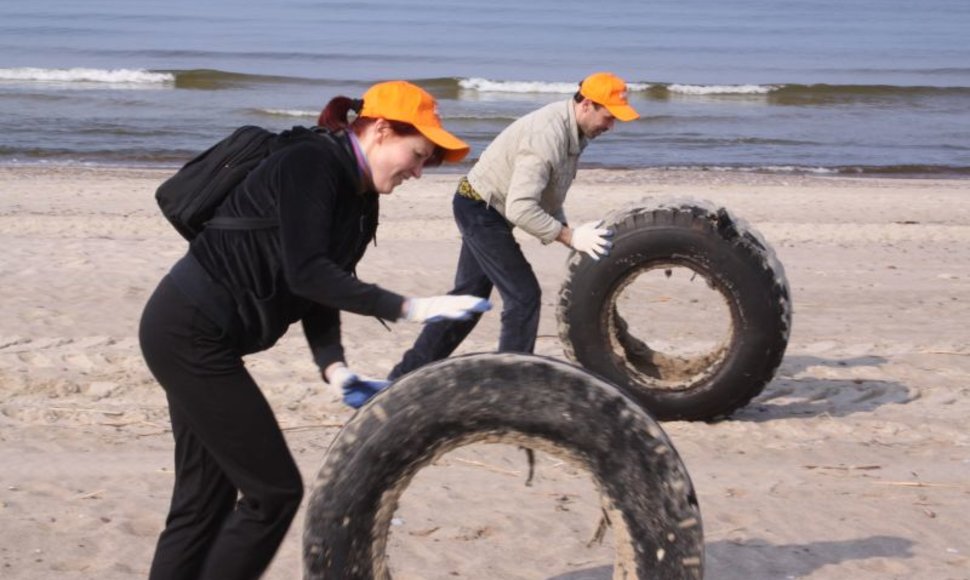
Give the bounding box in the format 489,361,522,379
139,81,490,580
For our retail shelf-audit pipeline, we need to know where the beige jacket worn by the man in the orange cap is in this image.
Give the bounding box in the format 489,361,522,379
468,99,588,243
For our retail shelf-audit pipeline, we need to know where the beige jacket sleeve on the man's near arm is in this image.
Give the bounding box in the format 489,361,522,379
505,131,562,243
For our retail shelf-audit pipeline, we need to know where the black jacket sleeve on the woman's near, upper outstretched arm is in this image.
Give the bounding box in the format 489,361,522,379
273,145,404,320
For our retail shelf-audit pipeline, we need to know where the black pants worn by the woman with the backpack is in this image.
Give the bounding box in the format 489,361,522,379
139,276,303,580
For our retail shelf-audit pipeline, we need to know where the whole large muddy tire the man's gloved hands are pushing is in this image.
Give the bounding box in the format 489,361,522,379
557,199,791,420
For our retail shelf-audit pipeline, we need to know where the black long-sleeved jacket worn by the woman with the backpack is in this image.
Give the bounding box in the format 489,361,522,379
173,128,404,368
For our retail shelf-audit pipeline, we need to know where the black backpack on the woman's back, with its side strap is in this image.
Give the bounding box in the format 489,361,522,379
155,125,284,240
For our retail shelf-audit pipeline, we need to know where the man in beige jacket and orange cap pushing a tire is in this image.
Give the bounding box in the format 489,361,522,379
388,72,639,380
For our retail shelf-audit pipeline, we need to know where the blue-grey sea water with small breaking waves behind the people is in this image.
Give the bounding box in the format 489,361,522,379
0,0,970,175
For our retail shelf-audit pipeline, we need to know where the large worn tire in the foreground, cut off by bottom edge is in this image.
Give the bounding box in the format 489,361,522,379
303,354,704,580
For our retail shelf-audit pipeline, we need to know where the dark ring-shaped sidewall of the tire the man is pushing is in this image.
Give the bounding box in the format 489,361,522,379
560,219,786,419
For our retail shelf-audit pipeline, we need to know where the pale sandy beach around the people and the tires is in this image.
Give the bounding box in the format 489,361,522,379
0,167,970,580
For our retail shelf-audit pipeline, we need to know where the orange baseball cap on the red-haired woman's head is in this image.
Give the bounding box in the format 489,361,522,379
360,81,471,162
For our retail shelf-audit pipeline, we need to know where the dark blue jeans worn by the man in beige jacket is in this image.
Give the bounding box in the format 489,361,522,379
388,195,542,380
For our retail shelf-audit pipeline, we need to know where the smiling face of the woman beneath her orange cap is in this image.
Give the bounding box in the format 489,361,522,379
367,121,435,193
